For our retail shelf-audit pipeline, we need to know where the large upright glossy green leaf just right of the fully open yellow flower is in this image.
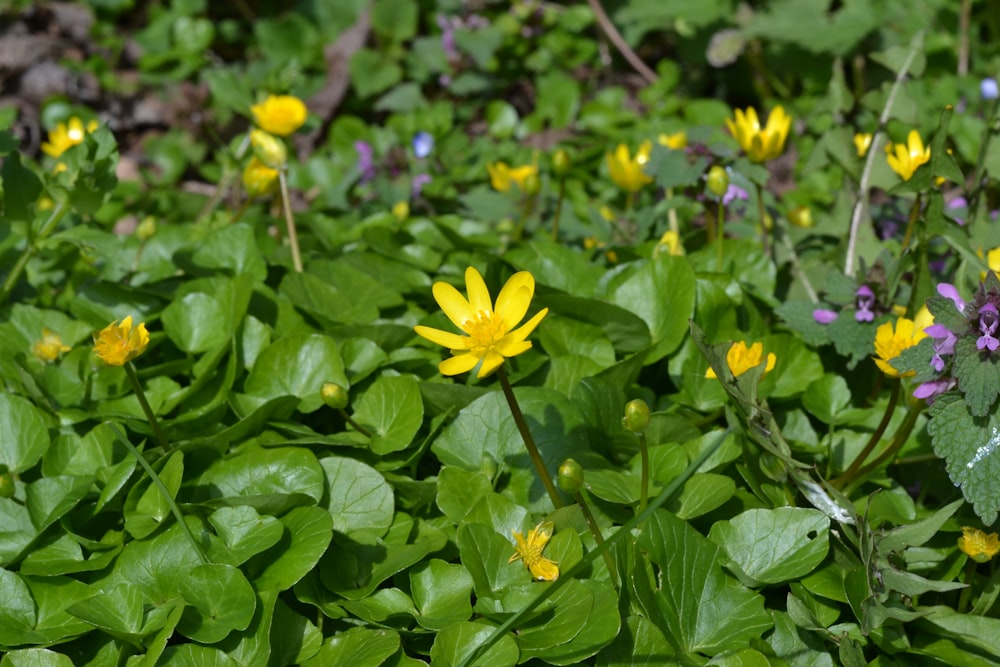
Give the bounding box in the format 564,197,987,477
610,255,695,364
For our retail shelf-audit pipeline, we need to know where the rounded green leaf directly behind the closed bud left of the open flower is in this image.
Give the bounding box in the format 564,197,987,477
245,334,348,413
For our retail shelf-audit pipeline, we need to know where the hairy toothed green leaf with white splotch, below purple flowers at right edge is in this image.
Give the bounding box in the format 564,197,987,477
927,392,1000,525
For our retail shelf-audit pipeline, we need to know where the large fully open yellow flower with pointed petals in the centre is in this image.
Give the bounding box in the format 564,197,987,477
413,266,549,378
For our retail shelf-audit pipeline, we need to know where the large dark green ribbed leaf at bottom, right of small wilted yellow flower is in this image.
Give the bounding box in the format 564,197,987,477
633,510,772,655
